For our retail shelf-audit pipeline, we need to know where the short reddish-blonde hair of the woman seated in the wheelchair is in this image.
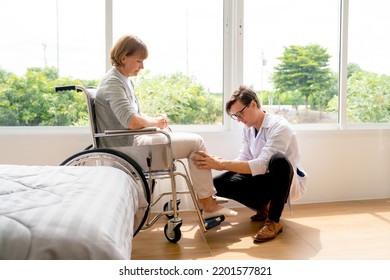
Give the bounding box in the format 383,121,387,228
111,35,148,66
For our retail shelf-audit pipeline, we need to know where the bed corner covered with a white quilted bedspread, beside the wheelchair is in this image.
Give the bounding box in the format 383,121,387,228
0,165,147,260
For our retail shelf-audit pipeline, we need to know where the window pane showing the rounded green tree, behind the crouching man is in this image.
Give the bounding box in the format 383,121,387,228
243,0,339,123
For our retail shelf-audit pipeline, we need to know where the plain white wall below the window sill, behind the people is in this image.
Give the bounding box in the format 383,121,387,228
0,128,390,206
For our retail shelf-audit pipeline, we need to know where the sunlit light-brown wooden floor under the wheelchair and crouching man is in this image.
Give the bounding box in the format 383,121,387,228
132,199,390,260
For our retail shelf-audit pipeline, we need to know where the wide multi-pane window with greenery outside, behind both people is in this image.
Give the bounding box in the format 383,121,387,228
0,0,390,129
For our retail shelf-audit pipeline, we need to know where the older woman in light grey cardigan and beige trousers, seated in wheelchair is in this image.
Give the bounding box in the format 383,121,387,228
95,35,237,218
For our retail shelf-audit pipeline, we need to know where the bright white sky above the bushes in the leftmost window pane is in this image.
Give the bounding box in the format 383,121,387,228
0,0,105,79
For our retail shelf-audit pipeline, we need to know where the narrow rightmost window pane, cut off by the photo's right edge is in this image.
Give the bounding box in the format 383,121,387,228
346,0,390,123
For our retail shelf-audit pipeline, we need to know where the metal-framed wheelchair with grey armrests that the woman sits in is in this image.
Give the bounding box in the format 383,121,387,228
55,85,225,243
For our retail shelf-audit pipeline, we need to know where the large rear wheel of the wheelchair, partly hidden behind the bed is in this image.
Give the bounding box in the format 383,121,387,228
61,149,151,236
